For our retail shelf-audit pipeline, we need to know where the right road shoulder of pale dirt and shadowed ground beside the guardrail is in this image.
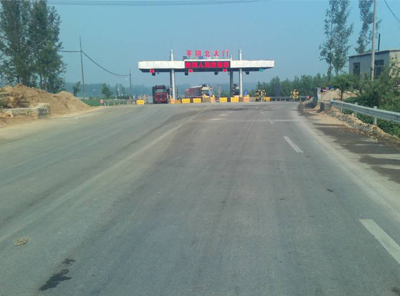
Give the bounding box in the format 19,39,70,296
298,100,400,221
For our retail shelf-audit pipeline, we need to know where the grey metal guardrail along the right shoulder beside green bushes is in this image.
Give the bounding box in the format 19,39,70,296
330,100,400,125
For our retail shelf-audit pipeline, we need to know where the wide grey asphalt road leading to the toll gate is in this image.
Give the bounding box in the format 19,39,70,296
0,102,400,296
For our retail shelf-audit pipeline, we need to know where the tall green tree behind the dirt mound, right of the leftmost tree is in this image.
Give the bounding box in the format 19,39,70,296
28,0,66,93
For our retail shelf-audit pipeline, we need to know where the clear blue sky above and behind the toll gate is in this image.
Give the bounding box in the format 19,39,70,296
56,0,400,85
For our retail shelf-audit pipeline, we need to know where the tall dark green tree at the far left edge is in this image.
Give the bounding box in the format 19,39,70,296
0,0,35,86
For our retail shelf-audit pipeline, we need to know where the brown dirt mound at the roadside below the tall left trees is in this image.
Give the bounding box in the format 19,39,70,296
0,84,90,115
